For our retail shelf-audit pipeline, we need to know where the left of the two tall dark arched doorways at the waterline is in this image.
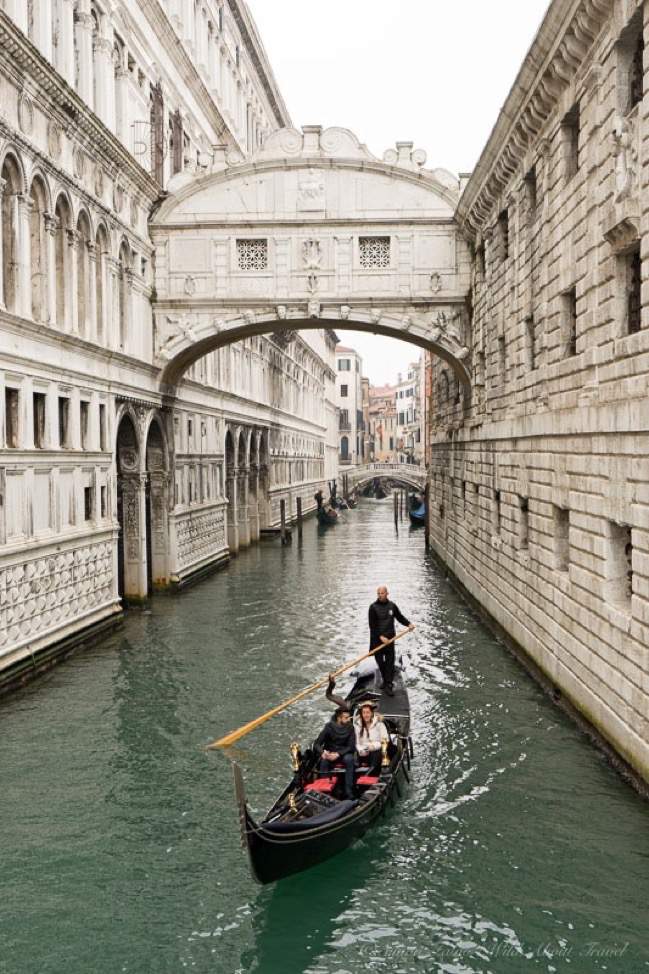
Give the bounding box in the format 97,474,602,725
116,413,146,601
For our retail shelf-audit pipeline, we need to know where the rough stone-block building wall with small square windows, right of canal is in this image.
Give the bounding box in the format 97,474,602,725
429,0,649,778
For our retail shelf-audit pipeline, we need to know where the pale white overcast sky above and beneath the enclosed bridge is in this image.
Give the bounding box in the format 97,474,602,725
248,0,548,385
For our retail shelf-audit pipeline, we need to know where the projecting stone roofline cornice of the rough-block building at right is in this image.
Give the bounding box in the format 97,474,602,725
456,0,614,237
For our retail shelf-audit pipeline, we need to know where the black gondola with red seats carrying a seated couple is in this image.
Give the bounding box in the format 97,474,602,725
233,670,412,883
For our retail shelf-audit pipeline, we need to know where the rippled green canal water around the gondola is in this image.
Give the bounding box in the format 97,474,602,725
0,508,649,974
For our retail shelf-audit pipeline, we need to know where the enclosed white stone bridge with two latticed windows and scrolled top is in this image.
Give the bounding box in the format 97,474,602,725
150,126,470,396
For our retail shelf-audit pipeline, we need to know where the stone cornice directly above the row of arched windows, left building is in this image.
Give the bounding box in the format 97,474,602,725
0,10,160,201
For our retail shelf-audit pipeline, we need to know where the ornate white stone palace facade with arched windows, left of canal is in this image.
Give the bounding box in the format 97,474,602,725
0,0,335,684
